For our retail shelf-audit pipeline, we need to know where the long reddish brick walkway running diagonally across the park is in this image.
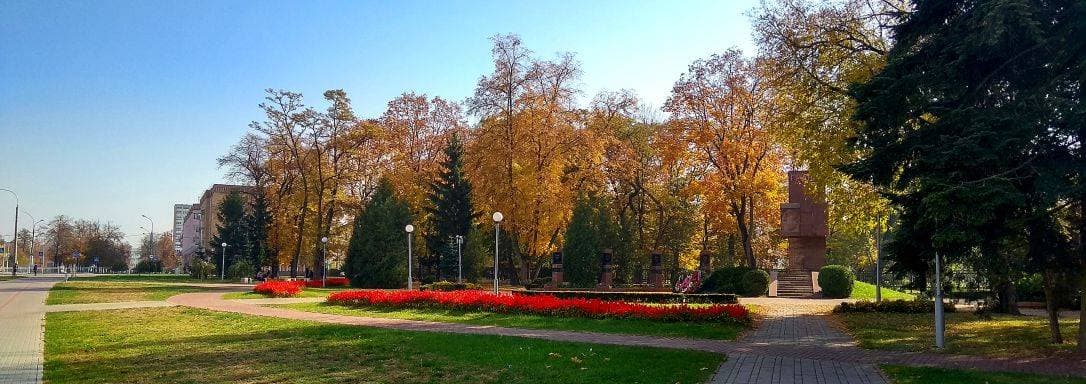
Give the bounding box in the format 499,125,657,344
167,292,1086,384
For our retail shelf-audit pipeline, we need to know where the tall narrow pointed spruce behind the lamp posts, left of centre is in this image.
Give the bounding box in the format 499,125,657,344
426,133,479,279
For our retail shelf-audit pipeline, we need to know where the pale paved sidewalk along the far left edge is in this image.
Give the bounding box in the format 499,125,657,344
0,278,63,384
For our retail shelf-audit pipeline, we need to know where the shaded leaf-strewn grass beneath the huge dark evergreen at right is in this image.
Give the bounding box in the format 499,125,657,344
835,312,1078,357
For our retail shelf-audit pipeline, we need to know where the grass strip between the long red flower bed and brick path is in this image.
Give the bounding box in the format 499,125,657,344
282,303,746,340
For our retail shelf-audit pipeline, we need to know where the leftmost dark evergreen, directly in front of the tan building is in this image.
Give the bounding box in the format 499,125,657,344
207,191,250,275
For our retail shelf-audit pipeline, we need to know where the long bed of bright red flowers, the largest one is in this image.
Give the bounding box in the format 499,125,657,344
328,291,750,324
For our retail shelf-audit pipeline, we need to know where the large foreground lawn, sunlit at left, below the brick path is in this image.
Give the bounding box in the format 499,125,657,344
45,307,723,383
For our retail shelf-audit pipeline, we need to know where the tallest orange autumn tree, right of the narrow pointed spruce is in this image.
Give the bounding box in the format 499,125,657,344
467,35,580,283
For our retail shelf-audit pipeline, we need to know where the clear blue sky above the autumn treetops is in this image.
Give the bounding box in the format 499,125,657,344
0,0,756,241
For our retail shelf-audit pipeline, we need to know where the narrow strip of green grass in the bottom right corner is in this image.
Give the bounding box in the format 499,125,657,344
882,366,1086,384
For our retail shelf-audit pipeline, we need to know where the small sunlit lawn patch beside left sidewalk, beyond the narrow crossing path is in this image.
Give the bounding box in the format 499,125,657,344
46,279,207,305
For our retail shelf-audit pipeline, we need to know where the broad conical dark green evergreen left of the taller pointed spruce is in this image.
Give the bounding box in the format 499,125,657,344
343,178,412,289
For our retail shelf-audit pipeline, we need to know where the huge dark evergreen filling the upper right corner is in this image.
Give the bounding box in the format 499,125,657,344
846,0,1086,347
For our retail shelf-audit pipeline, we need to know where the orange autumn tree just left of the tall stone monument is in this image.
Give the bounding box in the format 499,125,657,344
664,49,783,267
